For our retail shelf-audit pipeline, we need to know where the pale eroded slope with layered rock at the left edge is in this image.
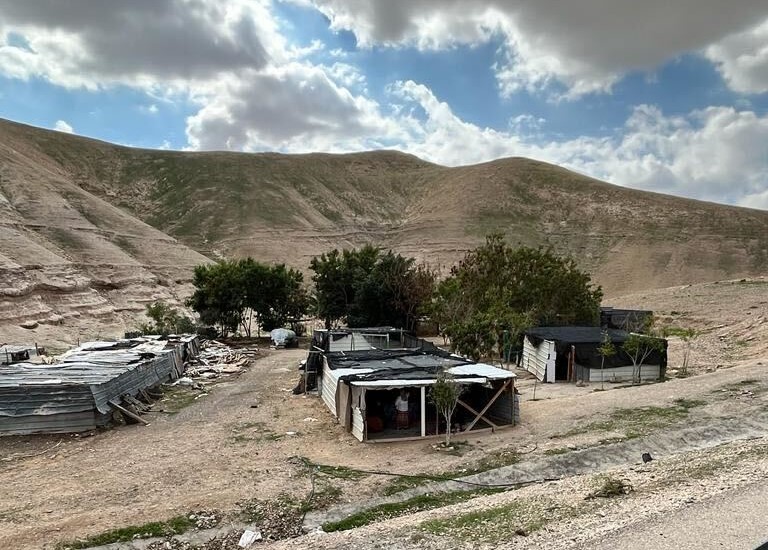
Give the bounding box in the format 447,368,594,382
0,120,208,348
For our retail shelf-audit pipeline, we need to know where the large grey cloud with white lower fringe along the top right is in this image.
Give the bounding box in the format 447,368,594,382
304,0,768,97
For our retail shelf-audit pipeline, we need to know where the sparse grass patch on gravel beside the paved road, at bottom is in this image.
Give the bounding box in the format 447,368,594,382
421,499,564,544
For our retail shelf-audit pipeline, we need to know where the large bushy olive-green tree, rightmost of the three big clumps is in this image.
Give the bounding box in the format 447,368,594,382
432,234,602,360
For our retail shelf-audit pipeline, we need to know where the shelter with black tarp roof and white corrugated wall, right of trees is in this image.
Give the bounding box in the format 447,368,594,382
520,327,667,382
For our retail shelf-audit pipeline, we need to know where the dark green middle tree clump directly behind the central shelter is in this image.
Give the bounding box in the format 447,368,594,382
309,245,435,330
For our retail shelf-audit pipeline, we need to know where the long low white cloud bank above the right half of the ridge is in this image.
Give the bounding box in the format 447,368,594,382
376,81,768,208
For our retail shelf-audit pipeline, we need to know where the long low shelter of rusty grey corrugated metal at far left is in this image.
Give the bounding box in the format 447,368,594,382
0,336,199,435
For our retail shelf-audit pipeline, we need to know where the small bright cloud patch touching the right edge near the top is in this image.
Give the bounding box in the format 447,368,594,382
706,20,768,94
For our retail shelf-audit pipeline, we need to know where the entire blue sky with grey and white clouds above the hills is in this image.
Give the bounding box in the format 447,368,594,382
0,0,768,209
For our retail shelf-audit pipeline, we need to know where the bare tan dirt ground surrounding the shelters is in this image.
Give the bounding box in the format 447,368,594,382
0,283,768,549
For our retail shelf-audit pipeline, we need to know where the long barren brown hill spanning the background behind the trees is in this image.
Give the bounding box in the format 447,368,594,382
0,117,768,324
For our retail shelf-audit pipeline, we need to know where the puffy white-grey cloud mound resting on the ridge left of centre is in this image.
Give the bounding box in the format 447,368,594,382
187,62,398,152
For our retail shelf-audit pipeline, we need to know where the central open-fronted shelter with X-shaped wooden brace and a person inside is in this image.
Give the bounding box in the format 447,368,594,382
319,348,519,442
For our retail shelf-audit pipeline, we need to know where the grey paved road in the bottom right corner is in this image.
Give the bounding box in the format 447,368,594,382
589,481,768,550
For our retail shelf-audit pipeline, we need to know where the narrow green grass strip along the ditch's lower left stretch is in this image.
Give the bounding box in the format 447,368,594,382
322,489,504,533
